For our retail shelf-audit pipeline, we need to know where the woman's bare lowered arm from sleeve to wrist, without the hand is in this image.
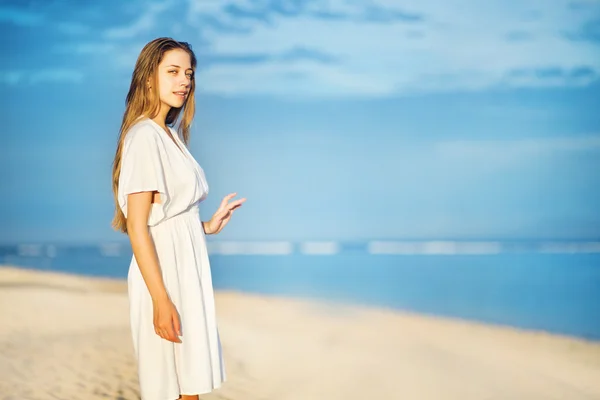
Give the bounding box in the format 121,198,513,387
127,192,168,302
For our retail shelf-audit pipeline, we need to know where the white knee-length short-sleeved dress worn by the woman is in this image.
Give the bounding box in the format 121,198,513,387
117,119,226,400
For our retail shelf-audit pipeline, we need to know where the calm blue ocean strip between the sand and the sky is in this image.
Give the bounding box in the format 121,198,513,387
0,242,600,340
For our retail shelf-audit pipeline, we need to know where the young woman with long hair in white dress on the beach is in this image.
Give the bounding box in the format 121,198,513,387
113,38,246,400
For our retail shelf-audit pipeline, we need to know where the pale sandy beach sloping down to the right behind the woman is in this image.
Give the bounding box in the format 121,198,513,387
0,266,600,400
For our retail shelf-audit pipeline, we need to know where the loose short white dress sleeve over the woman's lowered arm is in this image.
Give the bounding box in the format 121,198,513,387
118,127,170,226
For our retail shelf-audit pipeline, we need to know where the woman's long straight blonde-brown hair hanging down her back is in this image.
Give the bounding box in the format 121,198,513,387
112,38,196,233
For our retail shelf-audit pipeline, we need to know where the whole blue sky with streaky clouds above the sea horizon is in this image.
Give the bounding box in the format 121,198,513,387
0,0,600,242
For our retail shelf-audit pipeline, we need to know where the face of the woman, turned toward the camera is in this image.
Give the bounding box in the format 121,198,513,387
157,49,194,108
